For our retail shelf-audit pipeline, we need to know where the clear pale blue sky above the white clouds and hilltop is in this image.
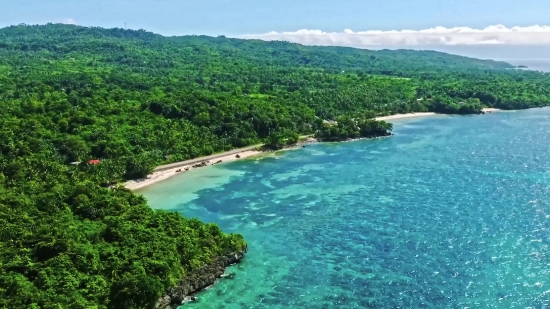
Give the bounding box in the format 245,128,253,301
0,0,550,36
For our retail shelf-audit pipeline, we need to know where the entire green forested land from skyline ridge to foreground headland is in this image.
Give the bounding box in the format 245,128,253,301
0,24,550,308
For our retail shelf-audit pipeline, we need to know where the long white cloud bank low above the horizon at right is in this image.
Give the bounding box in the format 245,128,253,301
240,25,550,47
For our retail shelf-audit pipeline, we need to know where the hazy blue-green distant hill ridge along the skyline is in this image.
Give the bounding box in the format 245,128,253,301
0,24,512,74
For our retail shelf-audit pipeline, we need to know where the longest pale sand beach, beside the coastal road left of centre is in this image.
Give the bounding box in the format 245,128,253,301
124,150,262,190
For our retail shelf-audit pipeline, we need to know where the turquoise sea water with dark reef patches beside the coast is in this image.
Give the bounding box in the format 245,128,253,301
142,109,550,308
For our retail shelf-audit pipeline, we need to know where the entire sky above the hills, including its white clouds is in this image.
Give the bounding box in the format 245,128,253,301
0,0,550,58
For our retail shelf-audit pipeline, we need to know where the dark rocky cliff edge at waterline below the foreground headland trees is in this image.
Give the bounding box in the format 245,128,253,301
155,248,247,309
